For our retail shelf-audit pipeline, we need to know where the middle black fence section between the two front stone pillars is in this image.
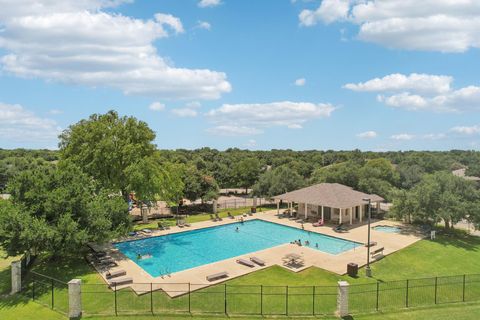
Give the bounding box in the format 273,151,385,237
82,283,337,316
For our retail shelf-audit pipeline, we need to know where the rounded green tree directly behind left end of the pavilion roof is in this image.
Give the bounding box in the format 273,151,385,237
253,166,305,197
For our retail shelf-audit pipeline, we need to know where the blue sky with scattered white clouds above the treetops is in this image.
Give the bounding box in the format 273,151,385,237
0,0,480,151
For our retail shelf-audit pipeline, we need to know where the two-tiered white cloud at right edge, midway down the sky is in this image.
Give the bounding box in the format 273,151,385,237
344,73,480,112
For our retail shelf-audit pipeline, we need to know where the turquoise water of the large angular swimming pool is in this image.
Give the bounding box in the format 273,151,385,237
115,219,361,277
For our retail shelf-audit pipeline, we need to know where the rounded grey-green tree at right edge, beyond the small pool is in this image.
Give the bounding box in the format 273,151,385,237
393,171,480,229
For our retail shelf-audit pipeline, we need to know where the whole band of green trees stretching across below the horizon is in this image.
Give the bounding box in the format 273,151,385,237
0,111,480,256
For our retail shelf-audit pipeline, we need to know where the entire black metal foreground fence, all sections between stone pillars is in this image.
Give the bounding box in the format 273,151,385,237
23,272,480,316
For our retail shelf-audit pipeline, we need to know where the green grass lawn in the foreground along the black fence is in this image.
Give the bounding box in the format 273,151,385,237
0,231,480,319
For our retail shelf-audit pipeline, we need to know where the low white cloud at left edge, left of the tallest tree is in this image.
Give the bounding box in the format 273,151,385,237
0,102,61,142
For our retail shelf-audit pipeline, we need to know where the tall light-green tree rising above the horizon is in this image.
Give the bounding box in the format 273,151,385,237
59,111,155,200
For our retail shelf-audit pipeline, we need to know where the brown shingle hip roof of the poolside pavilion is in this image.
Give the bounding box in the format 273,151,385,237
273,183,384,209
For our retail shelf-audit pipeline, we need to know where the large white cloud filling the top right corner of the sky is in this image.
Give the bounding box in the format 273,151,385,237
299,0,480,52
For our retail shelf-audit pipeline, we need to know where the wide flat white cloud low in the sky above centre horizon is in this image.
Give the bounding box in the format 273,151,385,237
206,101,335,135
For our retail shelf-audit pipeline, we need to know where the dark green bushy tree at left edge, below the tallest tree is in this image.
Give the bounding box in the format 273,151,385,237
0,162,130,256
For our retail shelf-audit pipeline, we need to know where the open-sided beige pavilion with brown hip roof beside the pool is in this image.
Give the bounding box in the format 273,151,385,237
273,183,384,224
